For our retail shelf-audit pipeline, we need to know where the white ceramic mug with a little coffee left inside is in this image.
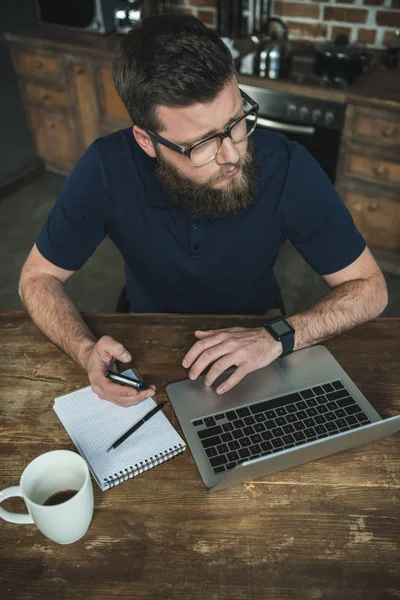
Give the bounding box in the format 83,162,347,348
0,450,93,544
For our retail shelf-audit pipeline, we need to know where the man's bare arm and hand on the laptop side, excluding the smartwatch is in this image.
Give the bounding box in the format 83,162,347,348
182,248,388,394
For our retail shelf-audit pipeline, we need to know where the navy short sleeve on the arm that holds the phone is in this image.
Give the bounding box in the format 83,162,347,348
36,142,108,271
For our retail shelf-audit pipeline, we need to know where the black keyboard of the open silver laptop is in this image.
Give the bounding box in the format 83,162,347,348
192,381,371,473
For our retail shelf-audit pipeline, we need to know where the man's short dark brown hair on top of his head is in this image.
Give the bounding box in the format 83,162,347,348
113,14,236,131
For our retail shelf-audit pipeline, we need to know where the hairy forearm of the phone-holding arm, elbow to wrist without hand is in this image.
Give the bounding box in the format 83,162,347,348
19,275,96,369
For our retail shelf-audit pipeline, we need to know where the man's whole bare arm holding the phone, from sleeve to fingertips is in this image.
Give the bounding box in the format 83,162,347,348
19,245,155,406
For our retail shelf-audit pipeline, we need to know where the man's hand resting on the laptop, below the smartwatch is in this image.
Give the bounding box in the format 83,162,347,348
182,327,282,394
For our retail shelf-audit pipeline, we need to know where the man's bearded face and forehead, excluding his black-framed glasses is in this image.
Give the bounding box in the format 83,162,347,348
155,79,257,219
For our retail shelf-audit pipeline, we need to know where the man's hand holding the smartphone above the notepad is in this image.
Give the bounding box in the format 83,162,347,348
86,335,156,407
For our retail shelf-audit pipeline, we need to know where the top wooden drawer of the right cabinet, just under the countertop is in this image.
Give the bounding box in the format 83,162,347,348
354,112,400,146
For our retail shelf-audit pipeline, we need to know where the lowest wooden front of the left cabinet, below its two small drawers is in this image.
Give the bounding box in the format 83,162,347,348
27,106,80,173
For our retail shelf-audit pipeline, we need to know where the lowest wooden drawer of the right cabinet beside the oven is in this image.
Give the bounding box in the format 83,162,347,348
343,191,400,251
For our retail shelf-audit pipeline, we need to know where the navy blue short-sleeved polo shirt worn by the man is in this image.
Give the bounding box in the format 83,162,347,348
36,128,365,314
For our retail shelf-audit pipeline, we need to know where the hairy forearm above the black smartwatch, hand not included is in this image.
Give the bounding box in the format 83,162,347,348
287,277,387,350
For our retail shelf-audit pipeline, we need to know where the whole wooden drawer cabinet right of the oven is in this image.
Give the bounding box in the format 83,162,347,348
336,104,400,274
